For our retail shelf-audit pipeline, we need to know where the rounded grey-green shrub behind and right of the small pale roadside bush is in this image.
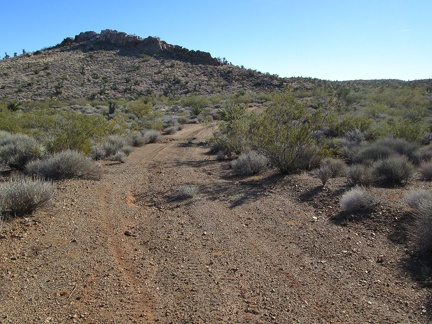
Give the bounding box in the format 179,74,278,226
372,156,414,185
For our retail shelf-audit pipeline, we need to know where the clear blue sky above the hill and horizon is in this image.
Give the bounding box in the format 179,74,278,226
0,0,432,80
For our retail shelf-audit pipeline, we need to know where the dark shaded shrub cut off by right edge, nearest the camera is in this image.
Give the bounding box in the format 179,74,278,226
410,199,432,256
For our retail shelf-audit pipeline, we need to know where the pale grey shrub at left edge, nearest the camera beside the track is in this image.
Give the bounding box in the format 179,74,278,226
0,177,55,216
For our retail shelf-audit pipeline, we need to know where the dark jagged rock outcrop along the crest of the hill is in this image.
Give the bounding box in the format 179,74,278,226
56,29,222,66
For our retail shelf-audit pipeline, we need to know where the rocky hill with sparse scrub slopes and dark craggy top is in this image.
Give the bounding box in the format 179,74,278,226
0,30,286,100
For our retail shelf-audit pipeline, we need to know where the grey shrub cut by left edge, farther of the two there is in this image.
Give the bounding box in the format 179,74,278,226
0,132,45,170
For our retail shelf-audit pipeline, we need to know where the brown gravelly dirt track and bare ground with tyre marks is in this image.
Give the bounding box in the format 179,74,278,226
0,125,430,323
